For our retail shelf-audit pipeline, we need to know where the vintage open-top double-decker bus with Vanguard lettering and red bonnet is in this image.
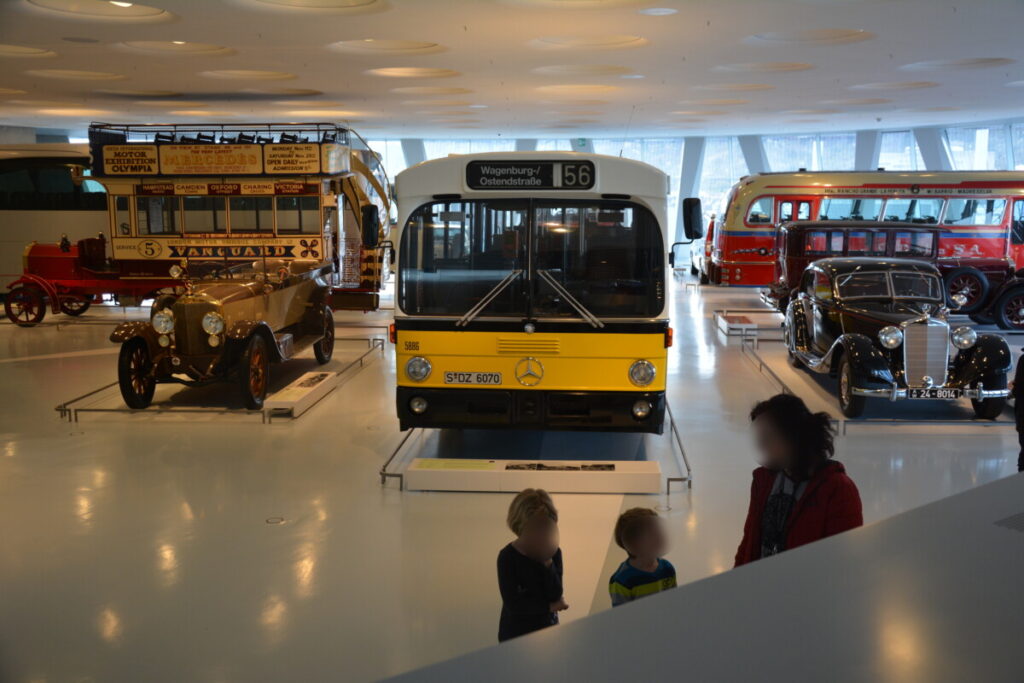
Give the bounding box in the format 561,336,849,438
4,123,391,327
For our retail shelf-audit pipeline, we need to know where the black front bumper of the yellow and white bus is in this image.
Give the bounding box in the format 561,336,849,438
396,386,665,434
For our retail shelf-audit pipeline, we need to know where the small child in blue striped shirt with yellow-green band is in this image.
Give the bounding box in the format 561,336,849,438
608,508,676,607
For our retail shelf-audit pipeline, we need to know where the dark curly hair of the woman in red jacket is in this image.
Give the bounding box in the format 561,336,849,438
751,393,836,478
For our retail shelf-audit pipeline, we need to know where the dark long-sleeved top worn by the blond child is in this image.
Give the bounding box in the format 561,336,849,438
498,543,562,641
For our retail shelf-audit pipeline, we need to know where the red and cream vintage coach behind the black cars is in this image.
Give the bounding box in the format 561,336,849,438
700,171,1024,287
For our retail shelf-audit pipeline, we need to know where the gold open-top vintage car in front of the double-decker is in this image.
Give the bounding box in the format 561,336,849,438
111,259,334,410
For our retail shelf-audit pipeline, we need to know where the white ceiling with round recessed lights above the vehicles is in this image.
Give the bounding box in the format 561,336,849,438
0,0,1024,137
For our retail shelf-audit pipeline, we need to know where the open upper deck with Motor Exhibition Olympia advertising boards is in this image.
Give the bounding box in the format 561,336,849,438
89,123,349,179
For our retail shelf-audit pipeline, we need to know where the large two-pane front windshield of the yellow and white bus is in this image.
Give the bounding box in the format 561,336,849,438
398,200,665,318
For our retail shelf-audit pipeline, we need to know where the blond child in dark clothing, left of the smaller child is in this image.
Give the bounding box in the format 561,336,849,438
498,488,569,641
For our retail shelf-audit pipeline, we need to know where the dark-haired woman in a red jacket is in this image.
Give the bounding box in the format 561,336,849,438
736,394,864,566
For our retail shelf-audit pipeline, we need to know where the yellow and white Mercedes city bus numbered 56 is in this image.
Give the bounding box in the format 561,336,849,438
392,152,699,433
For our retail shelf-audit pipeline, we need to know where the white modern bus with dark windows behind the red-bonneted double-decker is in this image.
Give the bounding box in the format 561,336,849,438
0,144,106,291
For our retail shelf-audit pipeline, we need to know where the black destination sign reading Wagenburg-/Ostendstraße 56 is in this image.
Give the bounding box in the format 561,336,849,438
466,160,594,190
